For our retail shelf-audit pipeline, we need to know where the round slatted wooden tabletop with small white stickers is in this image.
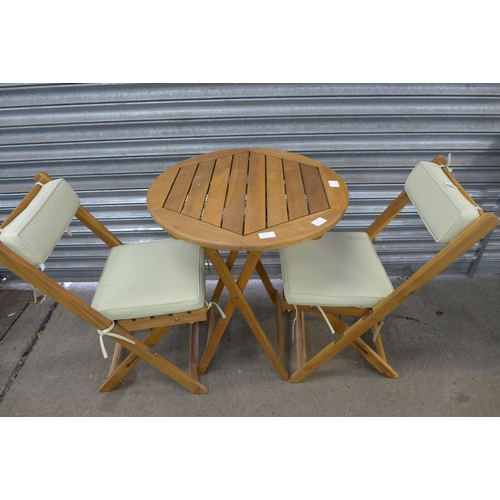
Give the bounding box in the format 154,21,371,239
147,148,348,251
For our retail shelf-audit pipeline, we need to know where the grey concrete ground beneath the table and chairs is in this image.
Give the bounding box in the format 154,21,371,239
0,272,500,417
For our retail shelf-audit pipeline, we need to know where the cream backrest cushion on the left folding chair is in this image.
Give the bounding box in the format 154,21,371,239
0,179,80,266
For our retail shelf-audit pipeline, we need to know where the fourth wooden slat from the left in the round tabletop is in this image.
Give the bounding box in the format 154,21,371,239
222,152,248,234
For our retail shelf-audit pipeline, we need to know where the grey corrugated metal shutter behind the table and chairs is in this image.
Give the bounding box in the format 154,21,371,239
0,84,500,280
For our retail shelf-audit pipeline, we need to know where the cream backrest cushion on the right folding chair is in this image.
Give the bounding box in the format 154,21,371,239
405,161,479,243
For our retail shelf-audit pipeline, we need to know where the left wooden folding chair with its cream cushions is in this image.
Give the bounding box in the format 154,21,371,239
0,172,208,394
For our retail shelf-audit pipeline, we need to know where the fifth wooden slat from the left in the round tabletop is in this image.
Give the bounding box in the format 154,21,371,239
244,152,266,234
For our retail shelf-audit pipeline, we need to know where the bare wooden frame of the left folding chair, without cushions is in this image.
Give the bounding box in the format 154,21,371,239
0,172,208,394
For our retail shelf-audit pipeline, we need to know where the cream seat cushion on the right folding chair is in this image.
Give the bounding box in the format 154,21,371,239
280,232,394,307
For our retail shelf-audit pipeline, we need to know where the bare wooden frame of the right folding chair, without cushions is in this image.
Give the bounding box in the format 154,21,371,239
283,155,499,382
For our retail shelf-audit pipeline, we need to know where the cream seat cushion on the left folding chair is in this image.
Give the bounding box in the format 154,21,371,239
92,239,205,320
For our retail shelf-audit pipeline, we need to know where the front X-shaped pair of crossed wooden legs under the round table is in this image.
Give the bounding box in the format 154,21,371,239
199,248,289,380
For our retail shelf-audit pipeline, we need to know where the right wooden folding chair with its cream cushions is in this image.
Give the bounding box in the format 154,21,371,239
280,155,499,382
